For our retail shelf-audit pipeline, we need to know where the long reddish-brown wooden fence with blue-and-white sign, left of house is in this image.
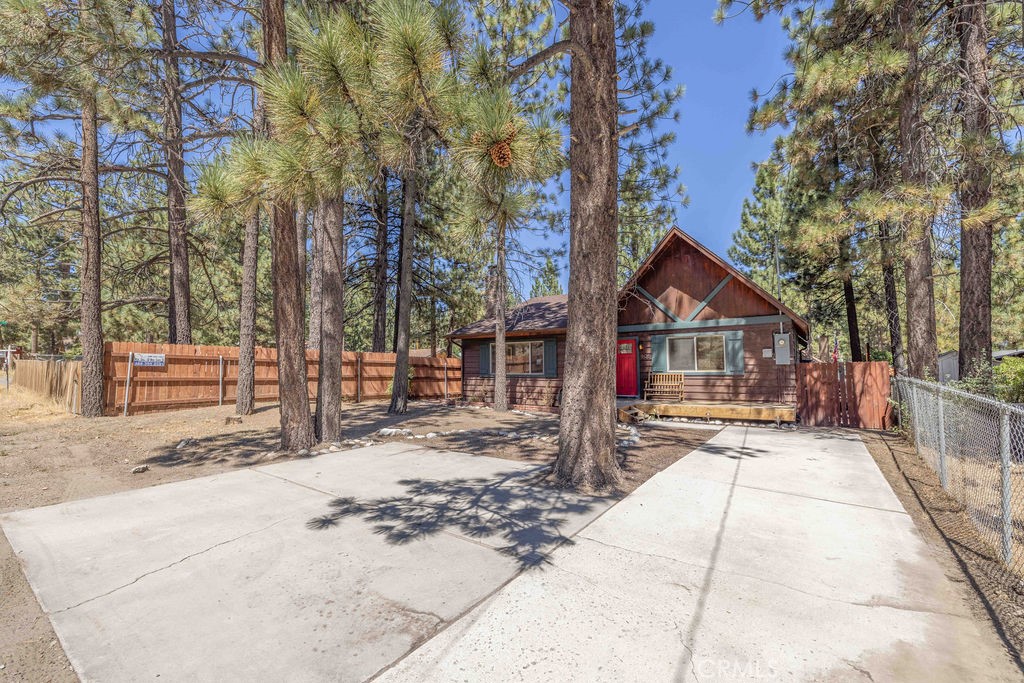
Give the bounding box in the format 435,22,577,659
103,342,462,415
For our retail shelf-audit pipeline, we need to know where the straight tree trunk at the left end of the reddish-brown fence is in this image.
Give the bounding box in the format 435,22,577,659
79,85,103,418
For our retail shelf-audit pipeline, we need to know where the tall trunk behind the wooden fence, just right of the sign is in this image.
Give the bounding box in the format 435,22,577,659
160,0,191,344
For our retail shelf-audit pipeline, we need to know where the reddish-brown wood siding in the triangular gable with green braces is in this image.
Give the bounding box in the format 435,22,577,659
618,240,779,325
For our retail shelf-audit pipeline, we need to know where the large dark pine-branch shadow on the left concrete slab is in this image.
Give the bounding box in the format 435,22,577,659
306,467,613,568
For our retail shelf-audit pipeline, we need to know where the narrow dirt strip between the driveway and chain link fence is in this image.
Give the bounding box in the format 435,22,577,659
857,432,1024,674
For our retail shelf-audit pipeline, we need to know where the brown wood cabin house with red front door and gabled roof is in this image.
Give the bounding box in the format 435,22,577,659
451,227,810,417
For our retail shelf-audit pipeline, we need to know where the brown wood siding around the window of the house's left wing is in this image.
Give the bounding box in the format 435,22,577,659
462,337,565,411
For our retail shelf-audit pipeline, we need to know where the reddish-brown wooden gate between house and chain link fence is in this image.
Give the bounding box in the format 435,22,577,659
797,360,893,429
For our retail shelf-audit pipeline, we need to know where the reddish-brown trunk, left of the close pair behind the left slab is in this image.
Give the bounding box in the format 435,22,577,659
262,0,315,451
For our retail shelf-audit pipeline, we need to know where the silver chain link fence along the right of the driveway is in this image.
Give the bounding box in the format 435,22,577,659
896,377,1024,578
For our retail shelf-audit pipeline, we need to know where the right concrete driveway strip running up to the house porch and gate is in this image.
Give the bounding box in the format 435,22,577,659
381,427,1021,683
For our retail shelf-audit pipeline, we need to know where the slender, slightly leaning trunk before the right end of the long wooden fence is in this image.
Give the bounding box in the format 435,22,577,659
387,167,416,415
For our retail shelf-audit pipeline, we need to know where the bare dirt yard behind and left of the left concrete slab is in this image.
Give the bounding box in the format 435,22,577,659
0,387,716,681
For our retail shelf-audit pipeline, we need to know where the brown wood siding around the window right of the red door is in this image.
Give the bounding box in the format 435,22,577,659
638,323,797,403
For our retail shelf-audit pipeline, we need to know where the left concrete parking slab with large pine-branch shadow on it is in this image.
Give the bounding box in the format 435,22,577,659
0,444,610,681
